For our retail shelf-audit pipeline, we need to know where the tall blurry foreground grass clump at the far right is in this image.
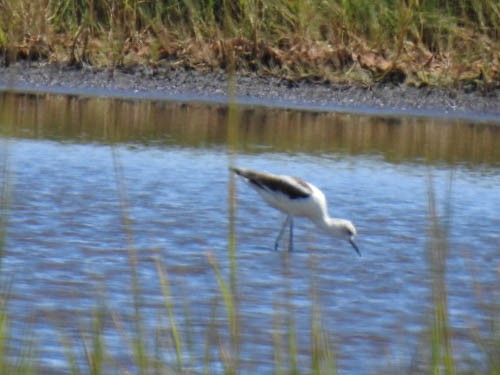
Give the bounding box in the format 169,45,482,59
425,173,500,375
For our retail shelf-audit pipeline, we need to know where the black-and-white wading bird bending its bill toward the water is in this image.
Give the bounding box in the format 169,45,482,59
231,168,361,256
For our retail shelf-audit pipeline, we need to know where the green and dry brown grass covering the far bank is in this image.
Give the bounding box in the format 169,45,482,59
0,0,500,90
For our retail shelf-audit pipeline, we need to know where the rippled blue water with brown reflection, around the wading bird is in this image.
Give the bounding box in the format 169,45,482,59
0,94,500,374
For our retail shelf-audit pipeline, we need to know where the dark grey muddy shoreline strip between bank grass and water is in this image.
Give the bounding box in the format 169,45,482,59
0,62,500,123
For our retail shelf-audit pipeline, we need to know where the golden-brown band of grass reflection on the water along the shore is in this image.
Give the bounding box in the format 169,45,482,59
0,93,500,164
